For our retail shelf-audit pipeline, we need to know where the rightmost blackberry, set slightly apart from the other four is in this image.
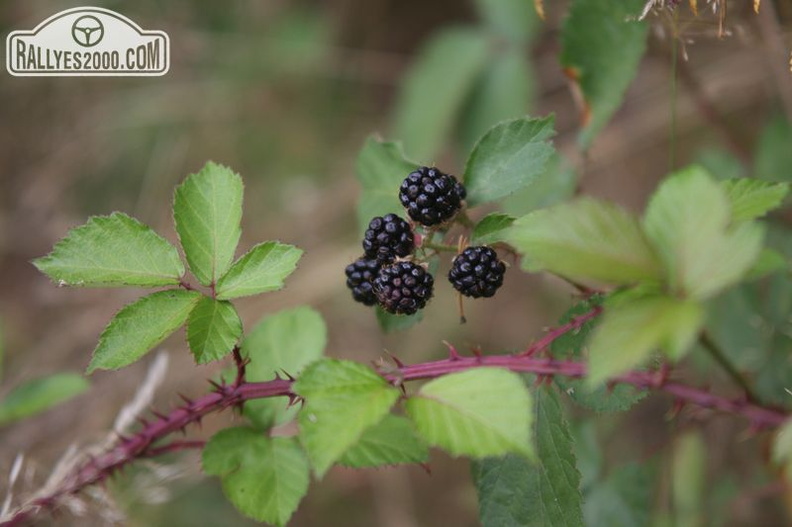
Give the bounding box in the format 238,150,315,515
448,247,506,298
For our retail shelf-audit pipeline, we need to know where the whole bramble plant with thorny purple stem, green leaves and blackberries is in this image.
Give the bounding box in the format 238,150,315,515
0,0,792,527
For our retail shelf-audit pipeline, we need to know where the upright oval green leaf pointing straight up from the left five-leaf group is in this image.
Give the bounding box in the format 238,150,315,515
173,162,243,286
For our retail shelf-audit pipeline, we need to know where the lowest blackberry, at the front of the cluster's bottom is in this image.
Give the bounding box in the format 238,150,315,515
374,262,434,315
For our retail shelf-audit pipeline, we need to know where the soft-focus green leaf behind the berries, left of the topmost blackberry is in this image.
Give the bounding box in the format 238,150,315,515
357,137,418,234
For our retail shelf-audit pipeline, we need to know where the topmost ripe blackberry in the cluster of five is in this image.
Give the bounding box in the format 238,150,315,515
399,167,467,227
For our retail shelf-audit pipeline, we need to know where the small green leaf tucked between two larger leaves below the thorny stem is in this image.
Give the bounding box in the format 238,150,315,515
338,414,429,468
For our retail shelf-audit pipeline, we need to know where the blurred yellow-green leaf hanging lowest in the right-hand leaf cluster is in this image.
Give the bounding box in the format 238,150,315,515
586,296,704,388
